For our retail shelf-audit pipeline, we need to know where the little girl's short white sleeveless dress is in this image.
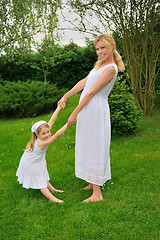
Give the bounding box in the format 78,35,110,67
16,141,49,189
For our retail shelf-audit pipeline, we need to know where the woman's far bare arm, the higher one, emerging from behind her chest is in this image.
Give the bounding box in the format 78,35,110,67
58,76,88,106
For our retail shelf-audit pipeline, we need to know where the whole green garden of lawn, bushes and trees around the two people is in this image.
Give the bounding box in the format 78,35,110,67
0,0,160,240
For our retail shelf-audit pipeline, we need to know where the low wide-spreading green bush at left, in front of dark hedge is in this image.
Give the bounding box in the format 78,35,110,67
0,81,66,118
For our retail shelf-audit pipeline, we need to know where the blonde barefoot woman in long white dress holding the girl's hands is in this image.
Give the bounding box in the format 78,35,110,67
59,34,125,202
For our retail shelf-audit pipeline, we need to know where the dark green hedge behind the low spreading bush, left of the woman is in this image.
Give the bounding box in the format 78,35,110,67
0,42,97,88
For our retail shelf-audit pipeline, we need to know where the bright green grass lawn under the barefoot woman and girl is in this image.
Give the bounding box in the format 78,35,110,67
0,95,160,240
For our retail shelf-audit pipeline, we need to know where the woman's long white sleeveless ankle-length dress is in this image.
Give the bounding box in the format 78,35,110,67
75,63,118,186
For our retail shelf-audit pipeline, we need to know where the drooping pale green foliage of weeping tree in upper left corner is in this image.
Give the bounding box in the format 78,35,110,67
0,0,60,58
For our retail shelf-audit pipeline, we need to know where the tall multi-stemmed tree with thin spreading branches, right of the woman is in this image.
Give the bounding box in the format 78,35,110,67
62,0,160,115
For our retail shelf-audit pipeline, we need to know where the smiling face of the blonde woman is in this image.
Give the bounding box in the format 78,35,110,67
95,41,113,62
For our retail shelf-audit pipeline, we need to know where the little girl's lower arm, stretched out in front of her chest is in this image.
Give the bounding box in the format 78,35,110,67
38,123,67,150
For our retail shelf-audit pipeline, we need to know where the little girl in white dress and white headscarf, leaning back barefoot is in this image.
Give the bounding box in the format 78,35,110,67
16,106,67,203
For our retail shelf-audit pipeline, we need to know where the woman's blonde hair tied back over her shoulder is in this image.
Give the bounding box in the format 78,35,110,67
94,34,125,72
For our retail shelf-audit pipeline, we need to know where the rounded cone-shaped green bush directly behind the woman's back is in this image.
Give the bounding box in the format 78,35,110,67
108,76,142,135
